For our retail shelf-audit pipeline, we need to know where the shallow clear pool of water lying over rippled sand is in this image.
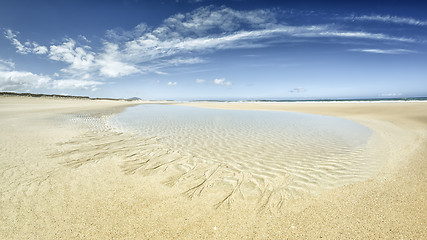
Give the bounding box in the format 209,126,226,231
109,104,382,202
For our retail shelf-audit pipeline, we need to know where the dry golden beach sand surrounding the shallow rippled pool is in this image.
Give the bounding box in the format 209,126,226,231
0,97,427,239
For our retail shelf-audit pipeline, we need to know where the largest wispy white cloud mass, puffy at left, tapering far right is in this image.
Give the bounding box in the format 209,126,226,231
6,6,414,78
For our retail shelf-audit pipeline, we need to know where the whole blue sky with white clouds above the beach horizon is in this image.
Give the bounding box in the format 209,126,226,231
0,0,427,100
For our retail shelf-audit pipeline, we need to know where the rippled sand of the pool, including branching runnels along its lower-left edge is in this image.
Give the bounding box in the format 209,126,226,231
61,105,381,211
